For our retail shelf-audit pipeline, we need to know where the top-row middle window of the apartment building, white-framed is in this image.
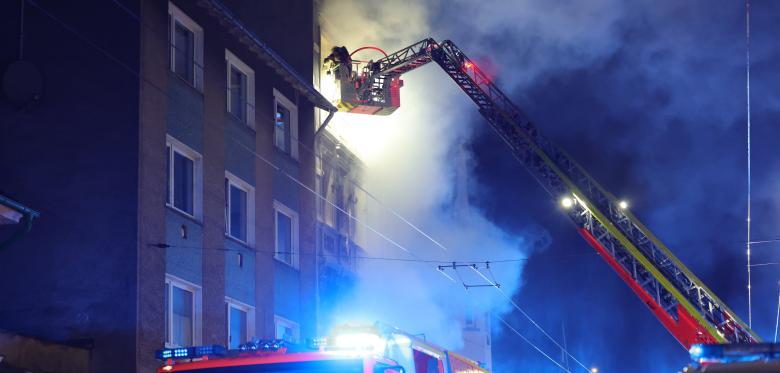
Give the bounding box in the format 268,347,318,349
225,49,255,128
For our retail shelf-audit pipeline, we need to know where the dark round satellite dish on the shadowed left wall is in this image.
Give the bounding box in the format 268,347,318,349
3,60,43,108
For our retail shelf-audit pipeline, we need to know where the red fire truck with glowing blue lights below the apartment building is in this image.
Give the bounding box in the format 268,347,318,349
156,324,489,373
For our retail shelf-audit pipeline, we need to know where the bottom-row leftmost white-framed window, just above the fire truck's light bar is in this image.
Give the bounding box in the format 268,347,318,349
164,275,201,347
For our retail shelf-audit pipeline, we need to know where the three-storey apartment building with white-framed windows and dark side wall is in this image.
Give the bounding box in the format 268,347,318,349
0,0,330,372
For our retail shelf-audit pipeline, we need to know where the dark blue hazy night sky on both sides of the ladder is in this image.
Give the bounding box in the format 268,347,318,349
434,1,780,372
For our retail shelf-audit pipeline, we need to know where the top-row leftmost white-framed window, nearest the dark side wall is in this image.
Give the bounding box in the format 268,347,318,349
168,3,203,90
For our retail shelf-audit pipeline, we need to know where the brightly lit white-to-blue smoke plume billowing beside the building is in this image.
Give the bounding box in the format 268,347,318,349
321,1,549,349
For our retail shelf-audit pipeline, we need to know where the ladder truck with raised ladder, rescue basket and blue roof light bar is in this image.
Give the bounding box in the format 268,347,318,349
323,38,780,372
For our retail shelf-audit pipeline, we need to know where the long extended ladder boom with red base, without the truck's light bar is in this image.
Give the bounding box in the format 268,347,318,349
330,39,759,349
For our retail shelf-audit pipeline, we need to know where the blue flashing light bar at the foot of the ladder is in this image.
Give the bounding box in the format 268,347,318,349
688,343,780,364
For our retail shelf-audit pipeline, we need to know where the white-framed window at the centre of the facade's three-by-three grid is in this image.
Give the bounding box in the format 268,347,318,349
225,171,255,245
